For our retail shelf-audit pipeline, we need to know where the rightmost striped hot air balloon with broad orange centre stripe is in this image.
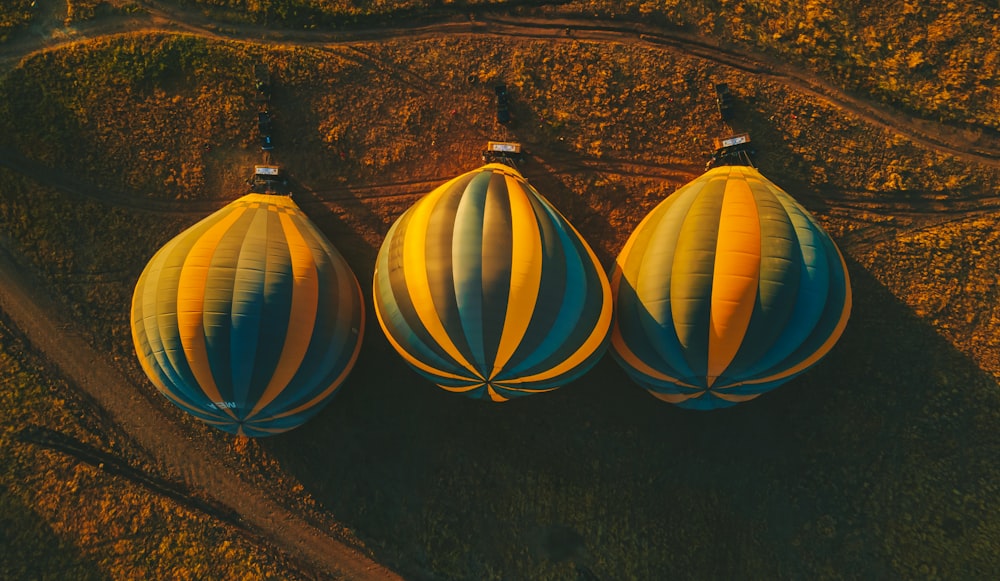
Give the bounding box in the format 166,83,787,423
611,166,851,409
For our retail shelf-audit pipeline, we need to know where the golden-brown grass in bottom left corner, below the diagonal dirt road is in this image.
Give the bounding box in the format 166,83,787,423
0,306,304,580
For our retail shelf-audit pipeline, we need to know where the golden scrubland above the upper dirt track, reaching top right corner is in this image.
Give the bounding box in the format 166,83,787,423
164,0,1000,132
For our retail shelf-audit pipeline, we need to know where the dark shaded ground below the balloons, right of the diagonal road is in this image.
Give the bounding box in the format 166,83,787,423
262,262,1000,579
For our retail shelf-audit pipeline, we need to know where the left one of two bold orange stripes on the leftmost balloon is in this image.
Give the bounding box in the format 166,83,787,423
177,208,246,419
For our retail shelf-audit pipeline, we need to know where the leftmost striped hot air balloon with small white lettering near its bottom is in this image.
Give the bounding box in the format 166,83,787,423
132,194,364,437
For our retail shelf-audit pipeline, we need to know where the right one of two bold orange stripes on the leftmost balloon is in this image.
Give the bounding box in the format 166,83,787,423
247,212,316,419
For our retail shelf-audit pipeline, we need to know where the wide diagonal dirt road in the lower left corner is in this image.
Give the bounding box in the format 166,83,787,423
0,239,401,580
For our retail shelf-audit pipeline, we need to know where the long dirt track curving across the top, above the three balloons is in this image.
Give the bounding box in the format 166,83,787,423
0,0,1000,167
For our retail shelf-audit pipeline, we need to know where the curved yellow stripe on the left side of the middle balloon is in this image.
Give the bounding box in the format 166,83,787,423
394,184,485,381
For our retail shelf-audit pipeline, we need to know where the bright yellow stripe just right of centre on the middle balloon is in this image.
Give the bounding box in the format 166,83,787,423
490,175,542,379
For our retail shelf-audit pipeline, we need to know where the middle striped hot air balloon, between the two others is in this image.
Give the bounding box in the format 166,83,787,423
374,164,612,401
